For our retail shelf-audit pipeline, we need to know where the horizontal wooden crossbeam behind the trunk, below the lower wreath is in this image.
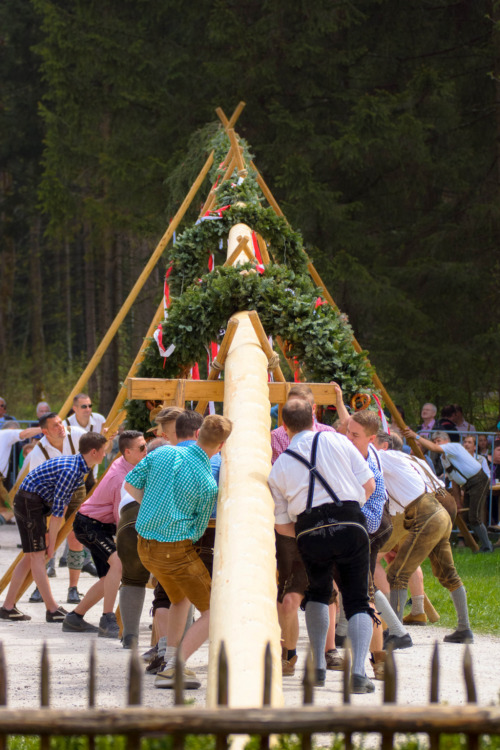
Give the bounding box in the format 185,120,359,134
127,378,336,406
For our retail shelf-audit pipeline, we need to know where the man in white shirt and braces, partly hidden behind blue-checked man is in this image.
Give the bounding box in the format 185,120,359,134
28,412,87,604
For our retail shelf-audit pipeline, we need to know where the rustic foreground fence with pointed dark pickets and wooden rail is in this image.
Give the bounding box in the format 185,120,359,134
0,643,500,750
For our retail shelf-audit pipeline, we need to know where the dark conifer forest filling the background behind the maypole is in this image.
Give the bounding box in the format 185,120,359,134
0,0,500,429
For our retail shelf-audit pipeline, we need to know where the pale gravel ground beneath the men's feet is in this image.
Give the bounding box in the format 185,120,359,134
0,526,500,708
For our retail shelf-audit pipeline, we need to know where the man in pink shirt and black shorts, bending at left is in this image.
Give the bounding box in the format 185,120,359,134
62,430,146,638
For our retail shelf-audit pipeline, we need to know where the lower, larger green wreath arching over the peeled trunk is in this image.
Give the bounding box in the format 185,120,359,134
127,263,373,430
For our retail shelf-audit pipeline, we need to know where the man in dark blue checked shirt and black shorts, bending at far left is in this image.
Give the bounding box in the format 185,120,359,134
0,432,107,622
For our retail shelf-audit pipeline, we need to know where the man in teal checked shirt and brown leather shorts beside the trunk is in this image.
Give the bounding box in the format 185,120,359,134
125,414,232,689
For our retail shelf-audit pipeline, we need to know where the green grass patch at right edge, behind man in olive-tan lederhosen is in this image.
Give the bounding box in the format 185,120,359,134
422,547,500,635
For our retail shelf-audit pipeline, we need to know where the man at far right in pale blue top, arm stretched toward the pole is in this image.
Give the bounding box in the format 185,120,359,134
405,430,493,552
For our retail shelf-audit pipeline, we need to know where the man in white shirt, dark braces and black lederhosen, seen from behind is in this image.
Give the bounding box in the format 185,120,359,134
268,399,375,693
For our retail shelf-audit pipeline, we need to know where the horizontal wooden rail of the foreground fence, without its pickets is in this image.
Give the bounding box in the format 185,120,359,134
0,703,500,736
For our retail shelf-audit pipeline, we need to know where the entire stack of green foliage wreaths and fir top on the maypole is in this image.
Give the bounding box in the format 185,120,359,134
127,129,373,430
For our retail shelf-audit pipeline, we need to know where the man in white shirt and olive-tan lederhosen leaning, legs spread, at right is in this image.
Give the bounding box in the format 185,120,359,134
375,431,474,643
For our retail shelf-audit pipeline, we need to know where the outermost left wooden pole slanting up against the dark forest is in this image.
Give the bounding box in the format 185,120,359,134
55,151,214,419
